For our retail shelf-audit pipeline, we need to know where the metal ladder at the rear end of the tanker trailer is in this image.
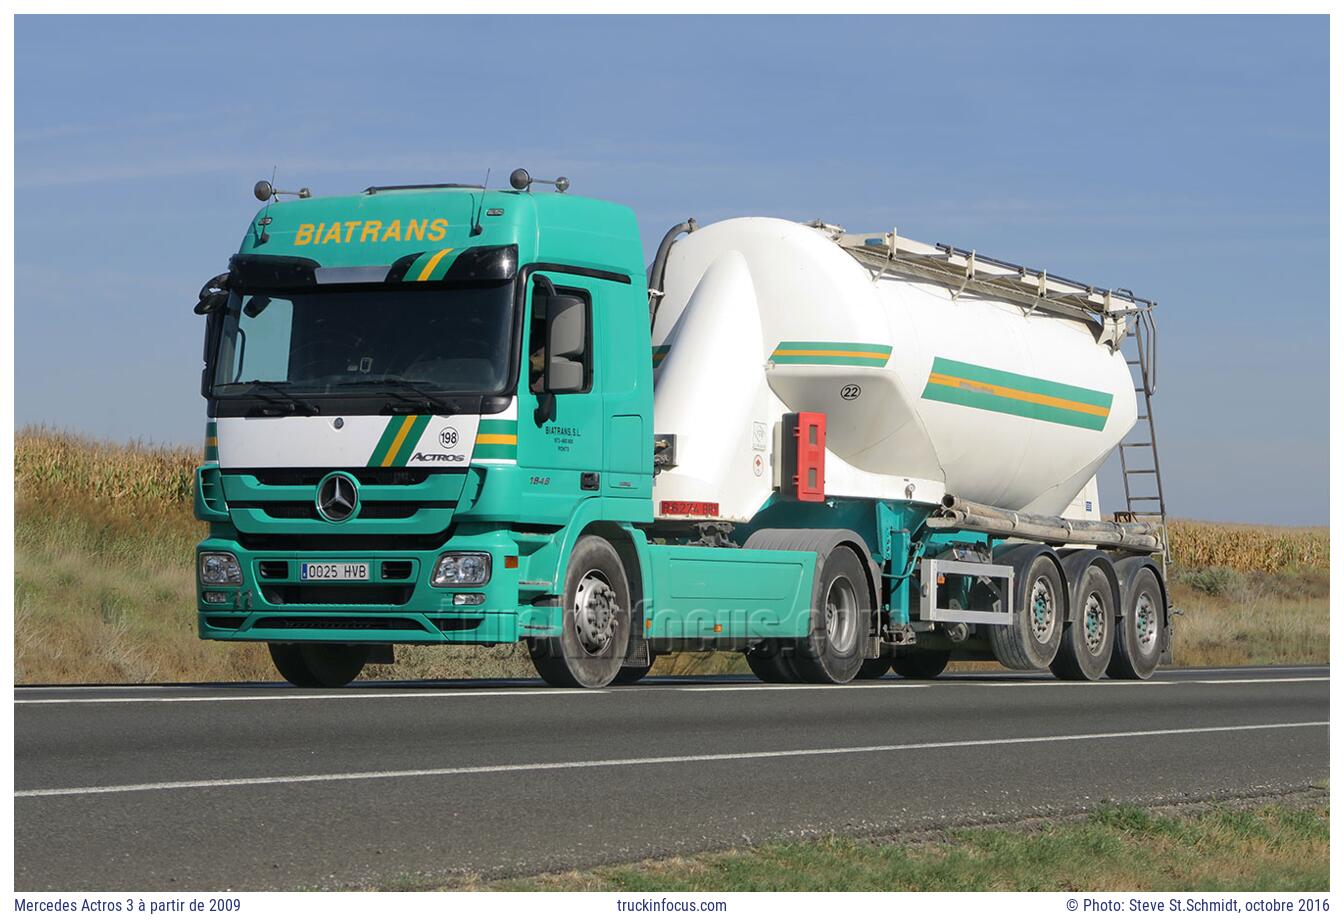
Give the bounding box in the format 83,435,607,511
1117,304,1171,566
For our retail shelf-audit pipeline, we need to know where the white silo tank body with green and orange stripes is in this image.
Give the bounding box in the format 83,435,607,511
653,218,1137,521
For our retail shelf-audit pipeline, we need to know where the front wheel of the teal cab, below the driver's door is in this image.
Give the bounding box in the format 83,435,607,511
527,535,630,688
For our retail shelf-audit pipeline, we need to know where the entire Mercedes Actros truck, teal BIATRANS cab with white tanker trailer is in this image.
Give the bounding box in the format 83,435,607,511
196,169,1171,688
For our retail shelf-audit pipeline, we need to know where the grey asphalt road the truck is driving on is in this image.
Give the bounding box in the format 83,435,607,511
15,668,1329,892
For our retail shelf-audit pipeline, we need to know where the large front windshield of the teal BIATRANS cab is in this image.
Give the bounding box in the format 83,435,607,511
211,281,513,398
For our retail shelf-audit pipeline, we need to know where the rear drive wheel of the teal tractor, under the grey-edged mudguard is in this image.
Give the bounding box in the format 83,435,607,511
793,545,872,684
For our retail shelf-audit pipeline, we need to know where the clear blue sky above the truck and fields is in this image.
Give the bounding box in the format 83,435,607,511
15,16,1329,524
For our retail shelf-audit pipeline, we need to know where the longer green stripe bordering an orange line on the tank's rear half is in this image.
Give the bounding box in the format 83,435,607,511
922,357,1114,431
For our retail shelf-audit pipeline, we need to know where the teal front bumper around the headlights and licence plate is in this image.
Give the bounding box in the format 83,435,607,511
196,531,560,645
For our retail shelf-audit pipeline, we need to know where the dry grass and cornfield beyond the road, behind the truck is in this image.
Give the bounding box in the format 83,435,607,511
15,428,1329,684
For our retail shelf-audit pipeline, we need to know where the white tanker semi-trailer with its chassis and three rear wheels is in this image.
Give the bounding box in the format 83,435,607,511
650,218,1169,680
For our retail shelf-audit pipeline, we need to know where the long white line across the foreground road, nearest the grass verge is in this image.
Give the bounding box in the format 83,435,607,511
13,721,1329,799
